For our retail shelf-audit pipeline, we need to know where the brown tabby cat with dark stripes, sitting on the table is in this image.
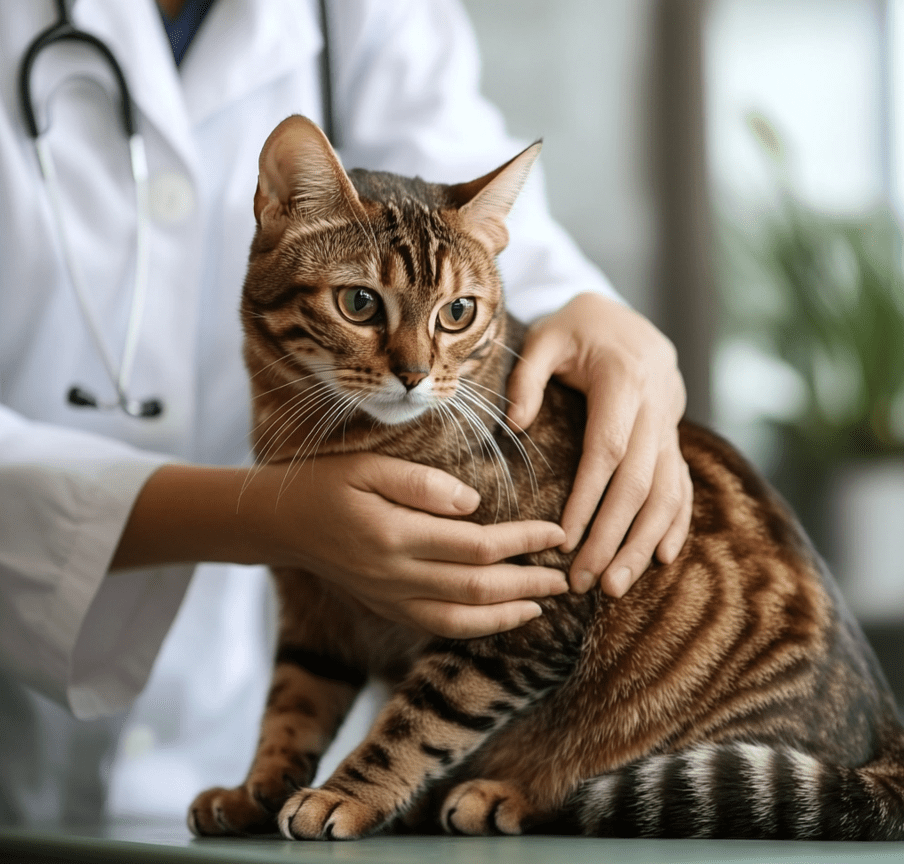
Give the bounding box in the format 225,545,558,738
189,117,904,839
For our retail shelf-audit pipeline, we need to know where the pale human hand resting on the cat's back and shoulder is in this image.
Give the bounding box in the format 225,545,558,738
508,294,693,597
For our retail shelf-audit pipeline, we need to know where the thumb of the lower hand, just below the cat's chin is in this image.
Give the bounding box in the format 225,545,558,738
361,456,480,516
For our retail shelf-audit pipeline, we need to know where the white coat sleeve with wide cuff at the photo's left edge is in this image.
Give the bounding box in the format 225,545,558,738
0,405,191,719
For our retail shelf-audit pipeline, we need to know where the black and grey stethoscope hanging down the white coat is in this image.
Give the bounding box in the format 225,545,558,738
19,0,163,418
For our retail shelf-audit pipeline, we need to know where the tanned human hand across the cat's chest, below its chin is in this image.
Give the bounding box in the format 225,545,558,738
243,453,568,638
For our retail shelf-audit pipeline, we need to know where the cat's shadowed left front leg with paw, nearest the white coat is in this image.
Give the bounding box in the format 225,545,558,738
188,646,366,836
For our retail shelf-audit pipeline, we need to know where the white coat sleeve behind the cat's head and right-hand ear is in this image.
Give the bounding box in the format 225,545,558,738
333,0,618,320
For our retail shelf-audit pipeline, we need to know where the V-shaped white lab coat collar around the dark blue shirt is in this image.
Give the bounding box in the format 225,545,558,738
73,0,322,173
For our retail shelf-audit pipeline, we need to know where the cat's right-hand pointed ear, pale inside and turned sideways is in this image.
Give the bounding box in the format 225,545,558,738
449,141,543,255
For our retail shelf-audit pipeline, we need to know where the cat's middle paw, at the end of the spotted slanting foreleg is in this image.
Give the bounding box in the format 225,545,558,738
279,788,386,840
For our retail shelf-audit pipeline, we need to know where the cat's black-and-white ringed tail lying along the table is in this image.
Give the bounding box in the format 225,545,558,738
572,743,904,840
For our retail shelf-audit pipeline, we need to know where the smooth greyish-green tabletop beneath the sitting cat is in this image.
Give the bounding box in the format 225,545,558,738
0,821,904,864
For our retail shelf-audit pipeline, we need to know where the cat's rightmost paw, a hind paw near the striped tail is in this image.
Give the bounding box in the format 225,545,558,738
440,780,533,835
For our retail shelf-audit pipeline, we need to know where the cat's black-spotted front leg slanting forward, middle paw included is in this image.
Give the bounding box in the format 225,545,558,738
279,600,583,839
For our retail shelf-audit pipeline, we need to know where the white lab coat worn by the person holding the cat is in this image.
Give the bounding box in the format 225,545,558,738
0,0,611,821
